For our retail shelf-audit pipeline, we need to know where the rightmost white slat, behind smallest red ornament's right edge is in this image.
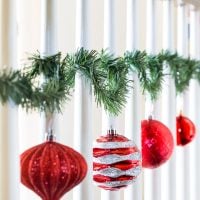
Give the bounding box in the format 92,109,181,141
188,6,200,200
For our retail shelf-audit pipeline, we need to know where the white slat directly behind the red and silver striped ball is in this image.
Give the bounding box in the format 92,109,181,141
101,0,120,200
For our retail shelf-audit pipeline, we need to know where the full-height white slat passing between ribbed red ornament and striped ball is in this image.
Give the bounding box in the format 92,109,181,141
73,0,93,200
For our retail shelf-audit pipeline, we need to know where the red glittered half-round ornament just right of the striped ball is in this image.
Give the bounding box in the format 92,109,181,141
141,119,174,168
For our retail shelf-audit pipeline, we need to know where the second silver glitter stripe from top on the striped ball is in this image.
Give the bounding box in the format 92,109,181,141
93,152,141,164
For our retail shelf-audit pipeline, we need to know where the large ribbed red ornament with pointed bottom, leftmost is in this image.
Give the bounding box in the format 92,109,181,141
21,131,87,200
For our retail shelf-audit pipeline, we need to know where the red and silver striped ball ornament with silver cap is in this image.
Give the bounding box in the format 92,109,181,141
93,130,142,190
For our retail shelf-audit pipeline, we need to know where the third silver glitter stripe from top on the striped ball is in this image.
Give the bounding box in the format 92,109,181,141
93,166,142,178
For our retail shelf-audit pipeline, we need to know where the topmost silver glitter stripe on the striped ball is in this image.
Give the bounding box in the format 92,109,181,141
93,141,136,149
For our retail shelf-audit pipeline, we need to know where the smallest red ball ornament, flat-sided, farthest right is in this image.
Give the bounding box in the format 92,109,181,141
176,114,196,146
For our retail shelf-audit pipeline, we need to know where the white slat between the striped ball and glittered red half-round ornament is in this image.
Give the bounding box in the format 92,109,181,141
124,0,143,200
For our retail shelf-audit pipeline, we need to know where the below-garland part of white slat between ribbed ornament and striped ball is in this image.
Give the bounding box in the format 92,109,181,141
73,74,93,200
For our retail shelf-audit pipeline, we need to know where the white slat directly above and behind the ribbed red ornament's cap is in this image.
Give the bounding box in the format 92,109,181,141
40,0,58,138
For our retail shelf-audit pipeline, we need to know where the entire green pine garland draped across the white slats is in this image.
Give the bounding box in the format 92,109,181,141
0,48,200,115
